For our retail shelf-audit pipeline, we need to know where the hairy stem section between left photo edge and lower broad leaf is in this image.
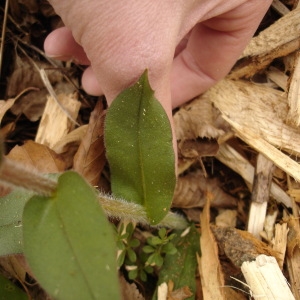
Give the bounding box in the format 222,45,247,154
0,157,57,197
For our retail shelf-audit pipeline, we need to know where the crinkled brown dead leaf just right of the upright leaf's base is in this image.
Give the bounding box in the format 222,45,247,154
173,170,237,208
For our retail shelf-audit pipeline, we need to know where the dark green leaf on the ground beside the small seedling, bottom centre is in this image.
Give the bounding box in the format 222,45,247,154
153,226,200,299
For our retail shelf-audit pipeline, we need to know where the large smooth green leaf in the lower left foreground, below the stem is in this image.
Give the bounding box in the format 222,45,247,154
23,171,120,300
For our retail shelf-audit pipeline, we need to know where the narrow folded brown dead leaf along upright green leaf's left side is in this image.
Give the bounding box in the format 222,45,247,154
74,101,106,185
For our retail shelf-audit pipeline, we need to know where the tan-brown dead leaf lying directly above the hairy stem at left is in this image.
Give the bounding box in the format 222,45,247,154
7,141,65,173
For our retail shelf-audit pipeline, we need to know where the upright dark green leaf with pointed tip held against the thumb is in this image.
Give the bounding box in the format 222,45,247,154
104,72,176,224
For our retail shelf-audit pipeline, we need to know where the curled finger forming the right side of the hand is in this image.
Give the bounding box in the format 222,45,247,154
171,0,272,107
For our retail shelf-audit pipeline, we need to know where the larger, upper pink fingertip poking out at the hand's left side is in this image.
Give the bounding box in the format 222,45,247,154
44,27,90,65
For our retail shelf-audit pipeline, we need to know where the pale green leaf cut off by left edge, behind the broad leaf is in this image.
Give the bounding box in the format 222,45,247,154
0,190,33,256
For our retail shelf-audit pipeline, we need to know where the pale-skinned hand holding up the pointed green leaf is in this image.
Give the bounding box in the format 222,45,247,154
45,0,272,157
